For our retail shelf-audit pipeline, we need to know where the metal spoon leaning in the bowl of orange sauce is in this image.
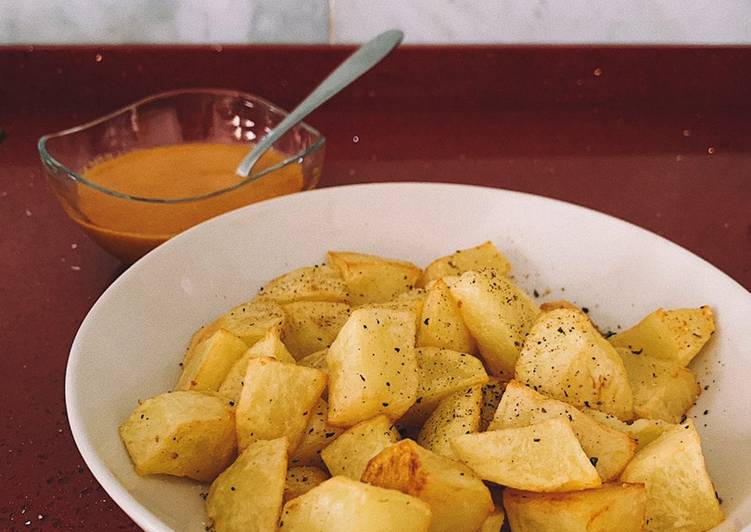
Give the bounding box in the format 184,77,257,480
235,30,404,178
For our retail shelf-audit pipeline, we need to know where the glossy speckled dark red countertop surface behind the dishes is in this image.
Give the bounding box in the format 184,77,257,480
0,46,751,530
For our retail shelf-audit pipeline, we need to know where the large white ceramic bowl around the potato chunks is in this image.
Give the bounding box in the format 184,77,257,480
66,183,751,531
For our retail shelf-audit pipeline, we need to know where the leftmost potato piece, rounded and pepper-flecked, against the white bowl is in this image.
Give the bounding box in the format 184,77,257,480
120,391,235,482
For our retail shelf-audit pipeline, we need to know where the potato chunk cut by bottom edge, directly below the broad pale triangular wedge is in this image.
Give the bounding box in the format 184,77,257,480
503,483,647,532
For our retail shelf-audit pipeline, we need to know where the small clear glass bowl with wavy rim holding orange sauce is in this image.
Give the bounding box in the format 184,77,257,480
38,89,325,262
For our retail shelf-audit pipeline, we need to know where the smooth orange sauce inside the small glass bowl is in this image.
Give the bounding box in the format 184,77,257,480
63,143,303,262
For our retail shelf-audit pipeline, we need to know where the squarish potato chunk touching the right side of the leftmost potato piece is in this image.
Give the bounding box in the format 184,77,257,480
235,357,326,454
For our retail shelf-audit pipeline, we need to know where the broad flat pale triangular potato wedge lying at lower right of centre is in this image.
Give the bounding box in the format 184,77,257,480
451,418,601,492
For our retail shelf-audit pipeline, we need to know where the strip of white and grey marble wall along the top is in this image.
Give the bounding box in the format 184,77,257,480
0,0,751,44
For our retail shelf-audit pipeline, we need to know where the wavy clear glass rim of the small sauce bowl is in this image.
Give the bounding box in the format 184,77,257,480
37,87,326,204
